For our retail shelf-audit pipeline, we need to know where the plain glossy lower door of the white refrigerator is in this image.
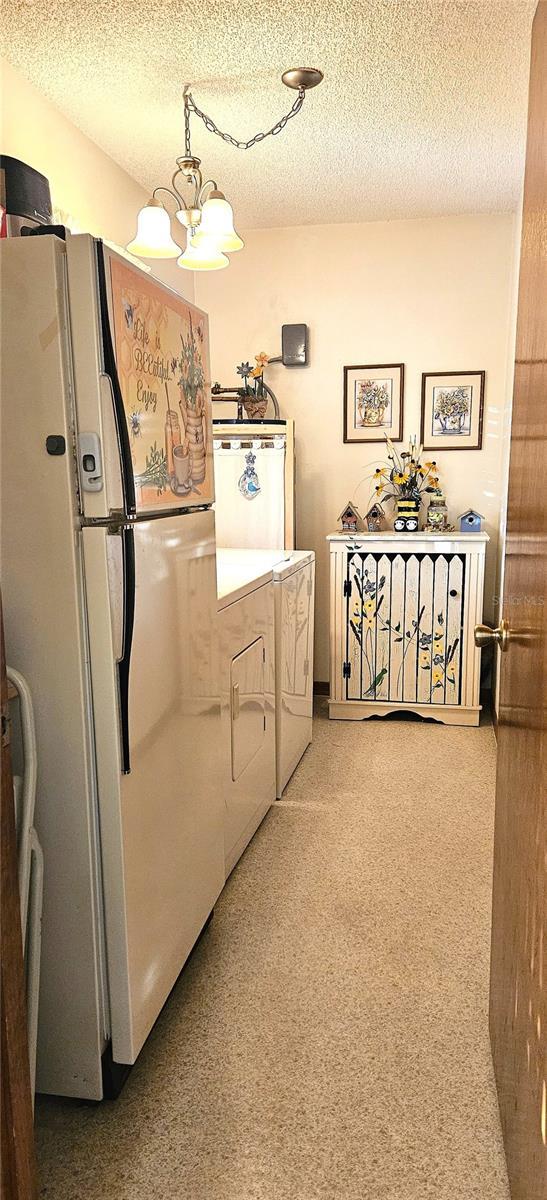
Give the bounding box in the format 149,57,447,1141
83,511,224,1063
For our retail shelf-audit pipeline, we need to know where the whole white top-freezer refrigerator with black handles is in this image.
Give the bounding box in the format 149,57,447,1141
0,234,224,1099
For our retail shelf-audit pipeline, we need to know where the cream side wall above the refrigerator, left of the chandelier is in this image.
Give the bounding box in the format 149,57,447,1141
0,59,194,300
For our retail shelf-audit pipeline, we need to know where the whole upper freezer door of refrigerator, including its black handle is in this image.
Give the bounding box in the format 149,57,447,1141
67,234,215,518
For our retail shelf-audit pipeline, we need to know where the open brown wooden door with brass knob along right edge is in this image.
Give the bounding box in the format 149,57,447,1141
489,0,547,1200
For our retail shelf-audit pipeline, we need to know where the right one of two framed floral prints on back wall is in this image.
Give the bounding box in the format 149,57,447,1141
420,371,485,450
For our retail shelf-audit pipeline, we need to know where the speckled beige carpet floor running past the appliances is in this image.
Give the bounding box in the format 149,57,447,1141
37,702,509,1200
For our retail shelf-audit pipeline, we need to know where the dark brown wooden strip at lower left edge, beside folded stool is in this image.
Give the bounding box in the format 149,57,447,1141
0,605,37,1200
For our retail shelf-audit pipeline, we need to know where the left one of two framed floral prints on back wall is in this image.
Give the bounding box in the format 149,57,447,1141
344,362,404,443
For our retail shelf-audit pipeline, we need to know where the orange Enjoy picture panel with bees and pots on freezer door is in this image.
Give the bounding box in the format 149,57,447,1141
100,247,215,514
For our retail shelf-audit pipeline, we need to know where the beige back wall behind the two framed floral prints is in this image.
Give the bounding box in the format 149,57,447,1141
196,215,515,679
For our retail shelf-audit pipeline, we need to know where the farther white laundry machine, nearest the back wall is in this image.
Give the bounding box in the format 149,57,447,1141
272,550,315,799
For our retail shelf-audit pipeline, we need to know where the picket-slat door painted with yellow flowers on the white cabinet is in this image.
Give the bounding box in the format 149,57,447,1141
343,551,465,704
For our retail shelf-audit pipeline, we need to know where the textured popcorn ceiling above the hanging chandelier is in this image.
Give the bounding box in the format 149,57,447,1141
2,0,535,228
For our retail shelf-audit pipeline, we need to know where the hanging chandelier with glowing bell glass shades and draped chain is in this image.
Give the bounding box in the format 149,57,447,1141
127,67,323,271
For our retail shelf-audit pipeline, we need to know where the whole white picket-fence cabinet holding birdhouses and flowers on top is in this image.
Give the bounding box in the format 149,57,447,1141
327,533,488,725
